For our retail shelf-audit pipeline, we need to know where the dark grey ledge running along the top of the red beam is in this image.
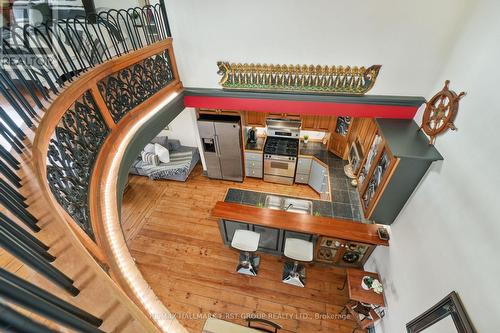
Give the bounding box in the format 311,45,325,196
183,87,426,107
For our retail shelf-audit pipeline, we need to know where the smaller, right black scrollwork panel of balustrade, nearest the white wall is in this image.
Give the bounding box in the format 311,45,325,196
97,50,175,123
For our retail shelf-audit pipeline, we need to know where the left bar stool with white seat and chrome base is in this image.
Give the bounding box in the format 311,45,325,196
231,229,260,276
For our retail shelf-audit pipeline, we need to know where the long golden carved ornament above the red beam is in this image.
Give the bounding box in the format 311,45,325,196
217,61,382,95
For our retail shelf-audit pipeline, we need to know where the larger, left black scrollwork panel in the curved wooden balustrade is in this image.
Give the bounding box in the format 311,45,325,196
47,91,109,240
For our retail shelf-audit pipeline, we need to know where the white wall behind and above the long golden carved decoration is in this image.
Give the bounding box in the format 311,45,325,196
166,0,473,96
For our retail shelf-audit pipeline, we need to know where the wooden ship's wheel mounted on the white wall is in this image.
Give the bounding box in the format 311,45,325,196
420,80,465,144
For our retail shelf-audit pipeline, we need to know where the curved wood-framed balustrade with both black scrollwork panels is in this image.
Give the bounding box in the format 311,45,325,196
36,39,179,253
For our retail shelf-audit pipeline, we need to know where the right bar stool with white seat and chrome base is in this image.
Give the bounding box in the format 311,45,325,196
283,238,313,287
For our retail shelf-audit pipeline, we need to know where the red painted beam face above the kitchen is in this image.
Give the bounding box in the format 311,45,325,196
184,96,418,119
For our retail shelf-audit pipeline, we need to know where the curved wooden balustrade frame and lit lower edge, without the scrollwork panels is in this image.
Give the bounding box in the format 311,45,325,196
33,38,186,333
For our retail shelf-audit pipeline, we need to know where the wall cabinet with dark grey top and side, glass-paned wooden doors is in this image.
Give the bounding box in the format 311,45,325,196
358,119,443,224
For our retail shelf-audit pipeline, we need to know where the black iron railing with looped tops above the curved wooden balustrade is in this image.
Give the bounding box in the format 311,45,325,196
0,4,171,128
